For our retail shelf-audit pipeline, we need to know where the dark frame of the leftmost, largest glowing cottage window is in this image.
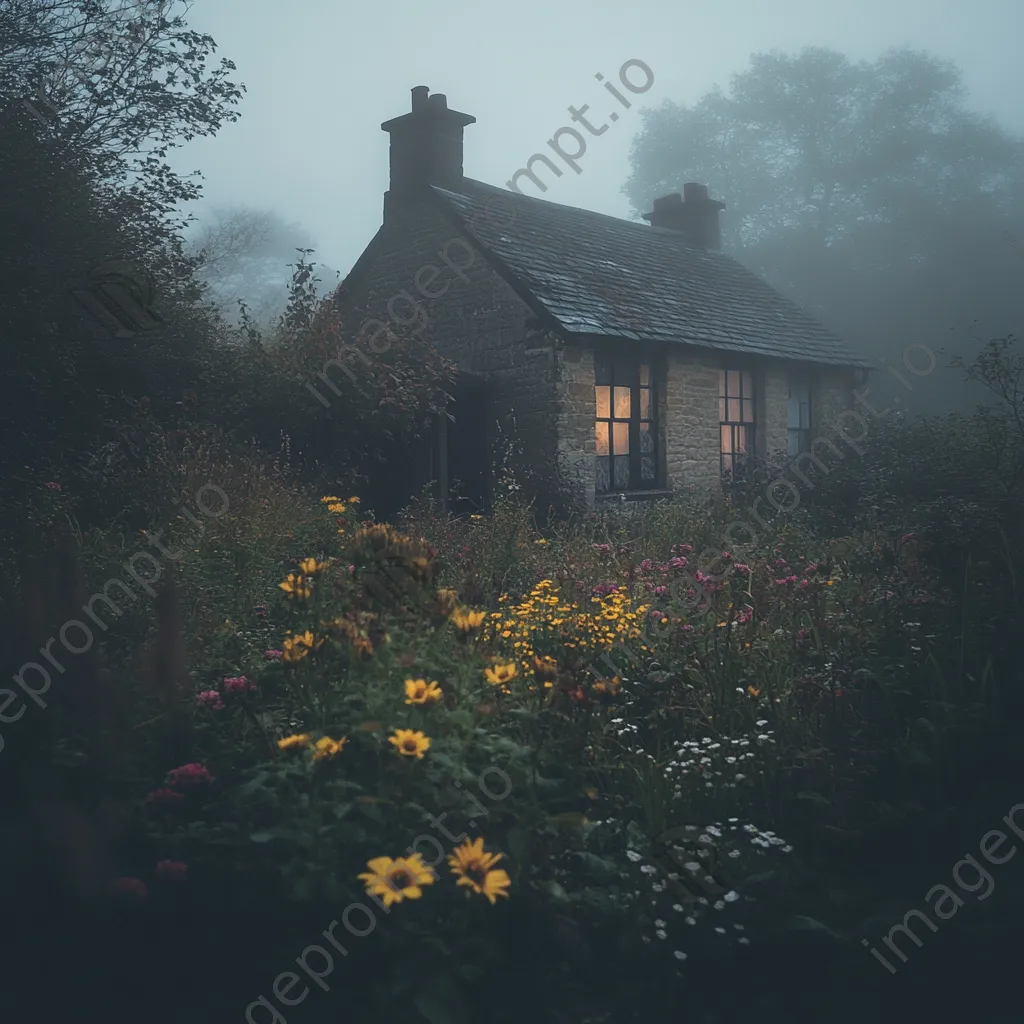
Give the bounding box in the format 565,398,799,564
594,350,662,496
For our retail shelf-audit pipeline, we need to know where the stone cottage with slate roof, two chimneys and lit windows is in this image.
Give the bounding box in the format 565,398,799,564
329,86,868,510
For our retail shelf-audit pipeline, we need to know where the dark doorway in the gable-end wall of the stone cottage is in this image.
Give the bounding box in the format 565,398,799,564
445,382,490,514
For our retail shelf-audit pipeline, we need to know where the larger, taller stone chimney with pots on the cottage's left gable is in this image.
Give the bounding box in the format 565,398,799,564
381,85,476,202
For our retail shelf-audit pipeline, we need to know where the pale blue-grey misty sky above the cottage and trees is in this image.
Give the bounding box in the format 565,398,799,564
174,0,1024,274
